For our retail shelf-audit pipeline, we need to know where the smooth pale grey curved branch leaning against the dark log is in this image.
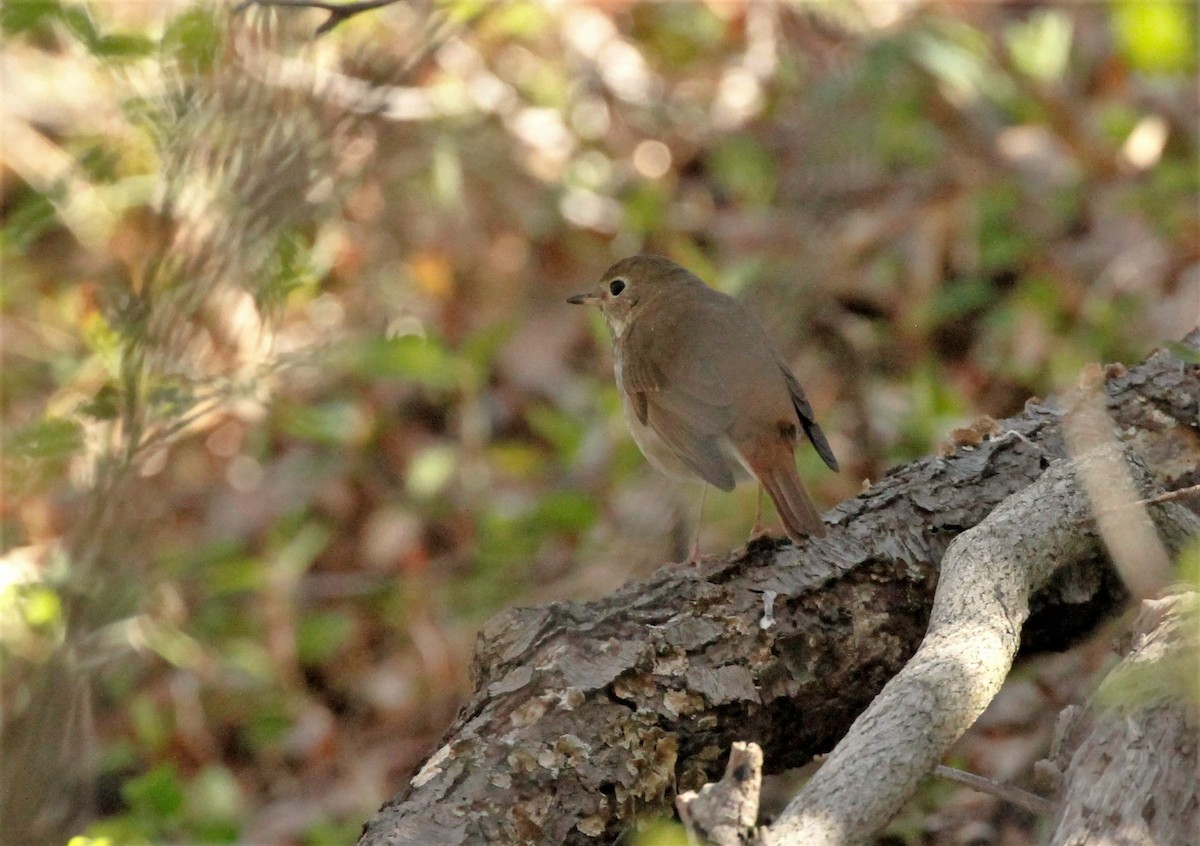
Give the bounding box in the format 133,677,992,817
761,443,1200,846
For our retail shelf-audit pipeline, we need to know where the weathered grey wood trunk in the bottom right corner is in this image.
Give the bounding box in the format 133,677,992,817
1050,593,1200,846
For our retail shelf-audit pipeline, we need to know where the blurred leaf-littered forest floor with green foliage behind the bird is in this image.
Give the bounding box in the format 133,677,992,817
0,0,1200,846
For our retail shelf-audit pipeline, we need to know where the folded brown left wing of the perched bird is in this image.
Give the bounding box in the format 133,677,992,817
622,309,736,491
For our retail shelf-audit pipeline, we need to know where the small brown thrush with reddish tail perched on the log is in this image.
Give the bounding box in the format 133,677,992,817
566,256,838,557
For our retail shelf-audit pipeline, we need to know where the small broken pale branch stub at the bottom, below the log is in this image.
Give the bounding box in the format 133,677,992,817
676,742,762,846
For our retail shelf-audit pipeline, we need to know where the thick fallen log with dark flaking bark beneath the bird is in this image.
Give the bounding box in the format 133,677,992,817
360,334,1200,846
